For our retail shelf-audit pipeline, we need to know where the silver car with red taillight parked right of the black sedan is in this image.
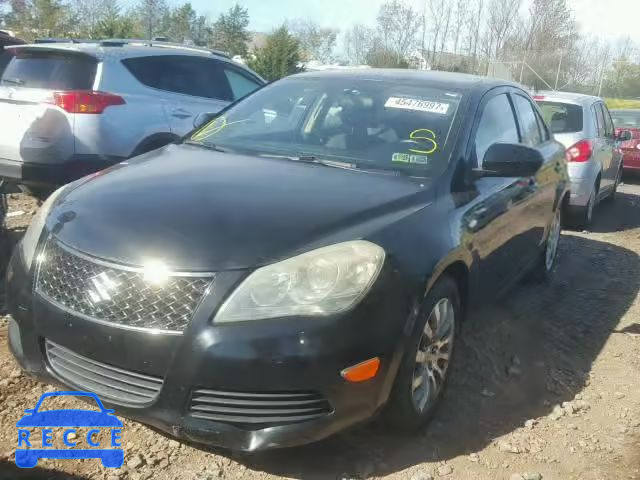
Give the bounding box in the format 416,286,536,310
534,92,623,228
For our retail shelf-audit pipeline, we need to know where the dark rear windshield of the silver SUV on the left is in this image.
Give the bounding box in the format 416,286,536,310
0,50,97,90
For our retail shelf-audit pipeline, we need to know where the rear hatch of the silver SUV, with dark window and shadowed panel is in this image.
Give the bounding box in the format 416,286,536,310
0,47,98,170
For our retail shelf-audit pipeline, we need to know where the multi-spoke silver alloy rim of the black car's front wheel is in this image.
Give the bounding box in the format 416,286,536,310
411,298,455,413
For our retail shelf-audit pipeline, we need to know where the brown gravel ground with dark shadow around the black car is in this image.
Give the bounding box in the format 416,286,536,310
0,179,640,480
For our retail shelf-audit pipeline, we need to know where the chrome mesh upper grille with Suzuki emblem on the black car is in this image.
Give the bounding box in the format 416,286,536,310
36,240,212,332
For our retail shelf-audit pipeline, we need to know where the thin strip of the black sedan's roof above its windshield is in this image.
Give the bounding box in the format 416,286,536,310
294,68,521,90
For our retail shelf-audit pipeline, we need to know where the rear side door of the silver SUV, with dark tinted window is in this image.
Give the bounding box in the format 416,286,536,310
123,55,233,136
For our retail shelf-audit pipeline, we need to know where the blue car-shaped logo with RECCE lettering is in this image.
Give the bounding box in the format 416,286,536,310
16,392,124,468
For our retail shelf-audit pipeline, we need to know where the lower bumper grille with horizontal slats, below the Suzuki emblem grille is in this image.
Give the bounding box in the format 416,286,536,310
45,340,162,405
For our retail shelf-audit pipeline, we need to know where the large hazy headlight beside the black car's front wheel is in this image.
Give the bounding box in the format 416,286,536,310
214,240,385,323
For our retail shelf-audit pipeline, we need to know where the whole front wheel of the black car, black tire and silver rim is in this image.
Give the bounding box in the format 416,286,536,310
386,276,462,431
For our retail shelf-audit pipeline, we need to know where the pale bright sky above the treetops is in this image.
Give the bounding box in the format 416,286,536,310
192,0,640,43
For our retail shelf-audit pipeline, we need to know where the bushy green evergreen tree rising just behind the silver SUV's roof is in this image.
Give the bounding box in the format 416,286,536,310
249,25,301,80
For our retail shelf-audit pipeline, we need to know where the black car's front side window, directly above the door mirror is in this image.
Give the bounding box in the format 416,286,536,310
475,93,520,167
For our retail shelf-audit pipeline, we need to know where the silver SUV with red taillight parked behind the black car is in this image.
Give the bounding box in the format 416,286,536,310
0,40,265,196
